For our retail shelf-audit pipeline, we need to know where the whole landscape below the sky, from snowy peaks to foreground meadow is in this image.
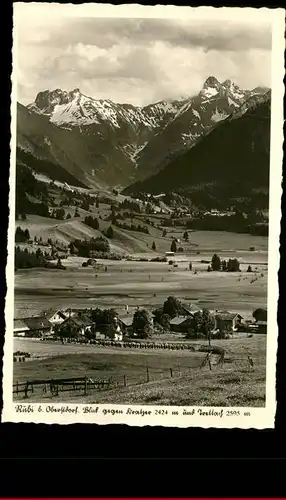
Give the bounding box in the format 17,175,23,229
11,77,271,406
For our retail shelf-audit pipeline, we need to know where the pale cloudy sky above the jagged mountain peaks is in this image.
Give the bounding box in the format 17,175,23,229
14,3,271,106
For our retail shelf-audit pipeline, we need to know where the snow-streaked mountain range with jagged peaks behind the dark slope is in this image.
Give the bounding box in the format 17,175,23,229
17,77,269,192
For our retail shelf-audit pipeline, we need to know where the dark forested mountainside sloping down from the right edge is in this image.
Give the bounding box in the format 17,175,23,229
124,91,271,209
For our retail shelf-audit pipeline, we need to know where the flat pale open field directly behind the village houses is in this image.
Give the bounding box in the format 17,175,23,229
15,252,267,317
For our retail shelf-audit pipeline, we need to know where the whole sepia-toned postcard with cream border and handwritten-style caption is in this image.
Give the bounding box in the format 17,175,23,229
2,2,285,429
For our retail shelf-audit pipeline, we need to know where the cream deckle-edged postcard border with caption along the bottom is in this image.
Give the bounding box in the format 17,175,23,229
2,2,285,429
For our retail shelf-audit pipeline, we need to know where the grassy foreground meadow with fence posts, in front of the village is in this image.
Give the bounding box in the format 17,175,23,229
14,335,266,406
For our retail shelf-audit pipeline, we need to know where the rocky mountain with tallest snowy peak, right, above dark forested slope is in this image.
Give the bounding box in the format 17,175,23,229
126,76,267,180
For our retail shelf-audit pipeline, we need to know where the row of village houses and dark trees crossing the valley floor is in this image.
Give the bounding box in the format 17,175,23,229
14,296,267,350
